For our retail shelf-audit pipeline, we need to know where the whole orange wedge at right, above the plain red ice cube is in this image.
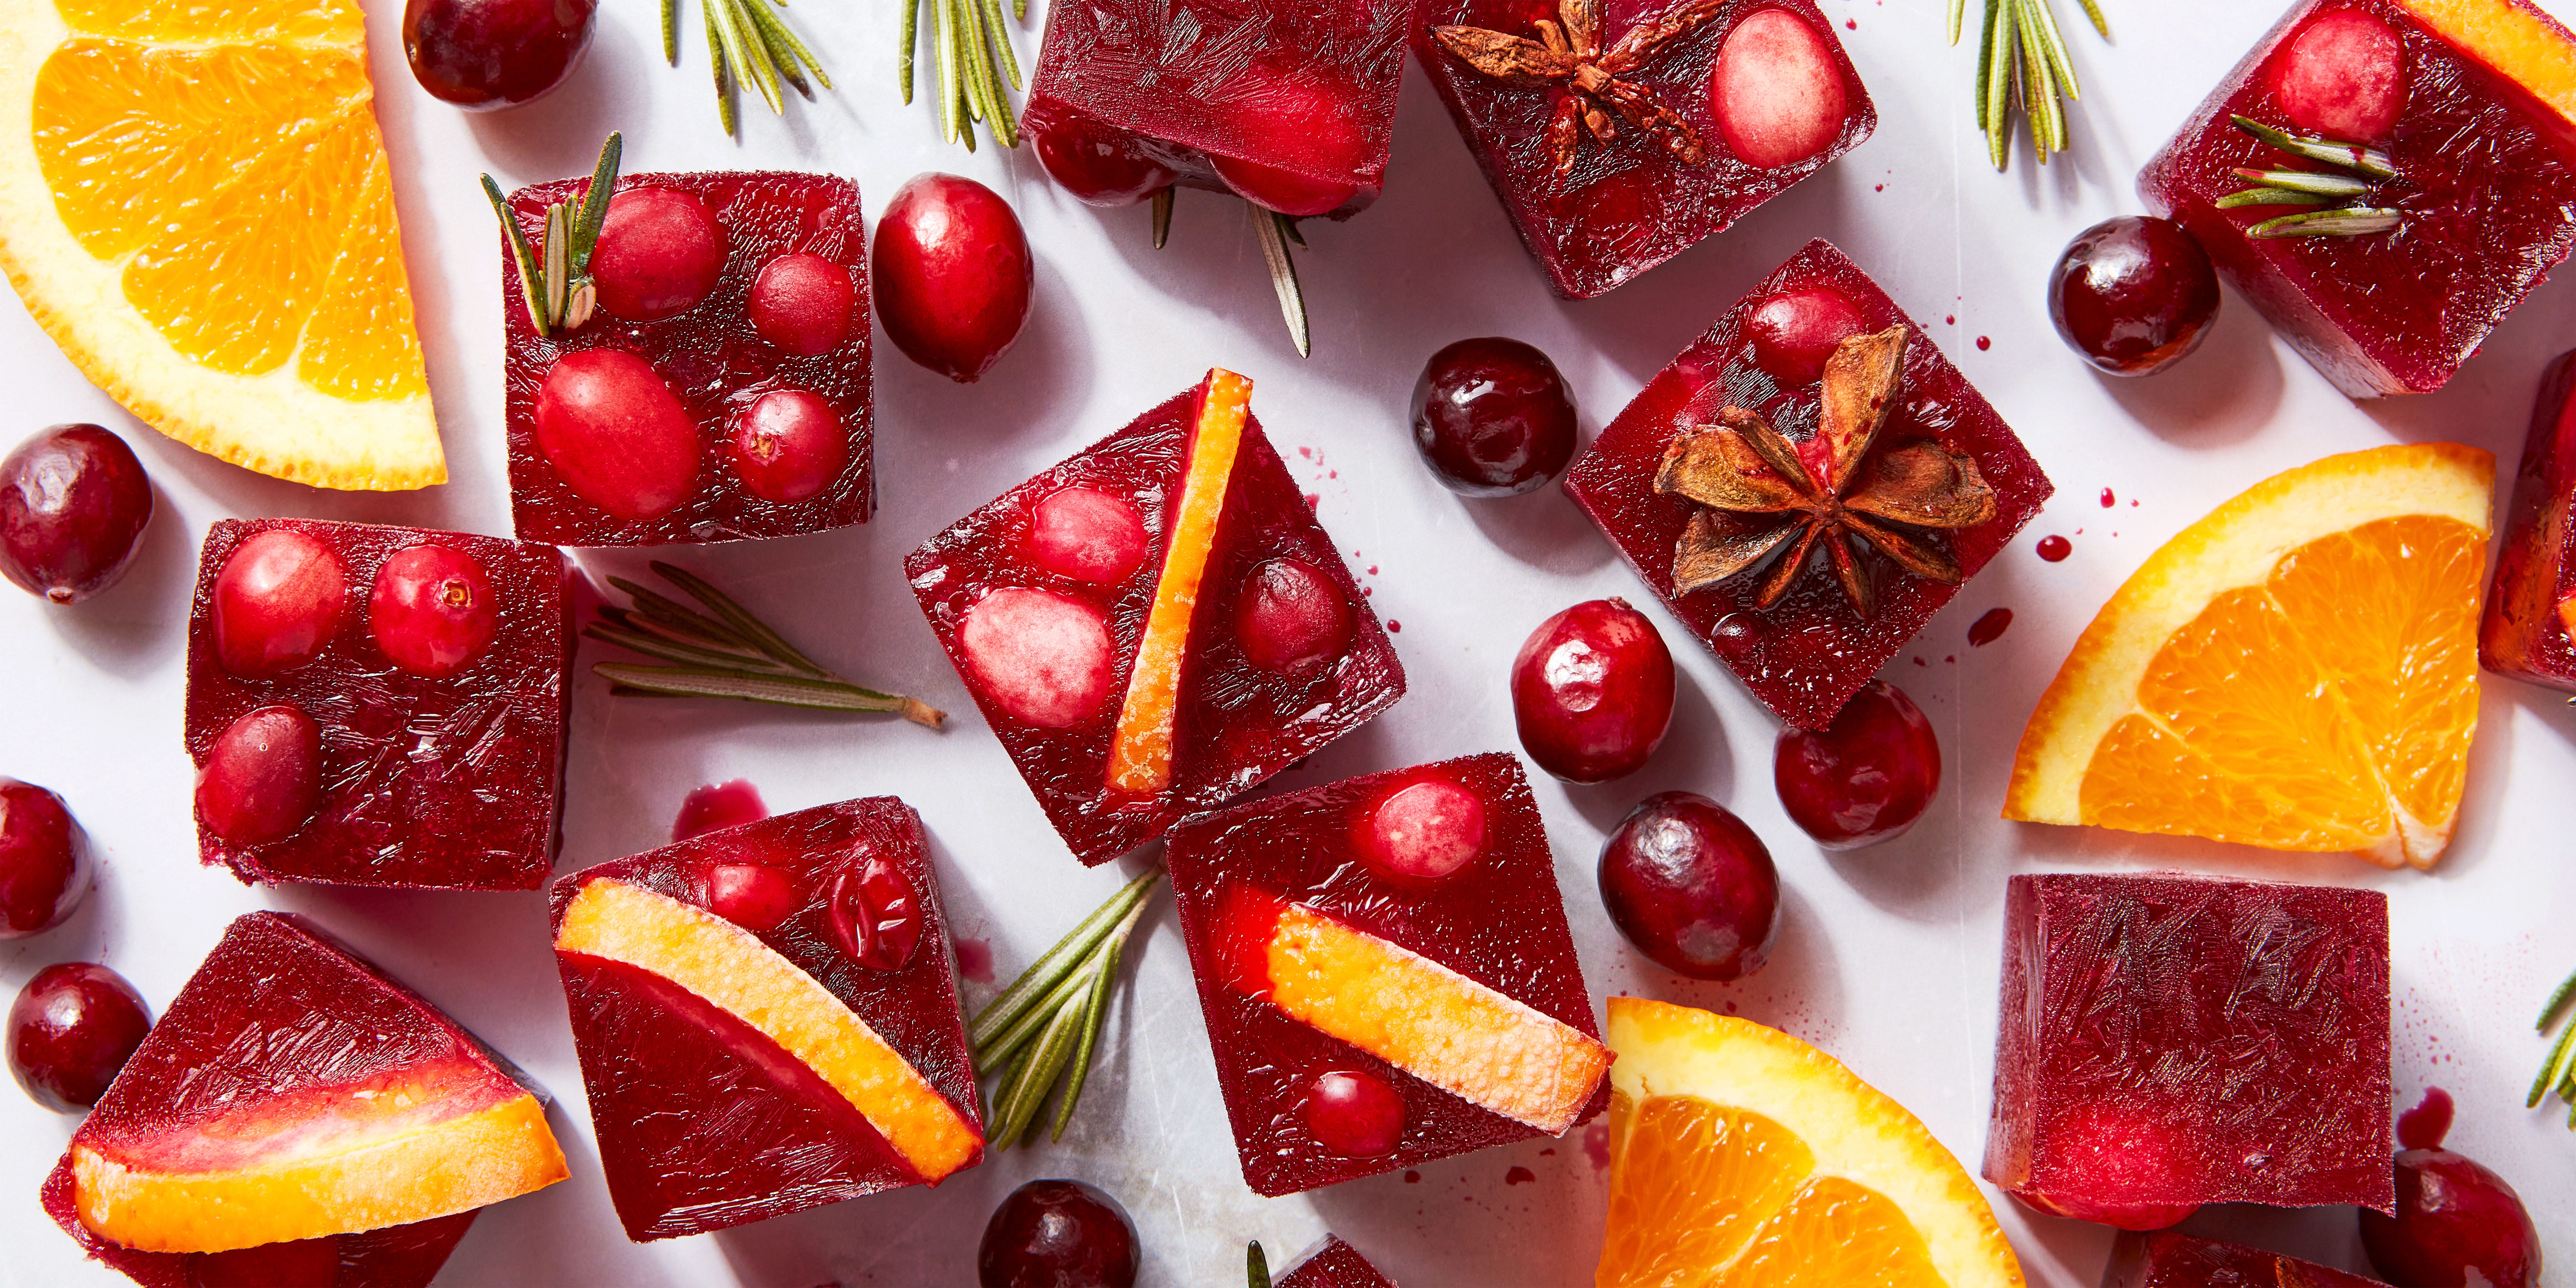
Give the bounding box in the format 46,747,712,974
2004,443,2496,868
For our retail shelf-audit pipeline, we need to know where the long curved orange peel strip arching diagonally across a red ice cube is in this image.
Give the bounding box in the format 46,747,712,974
554,878,984,1182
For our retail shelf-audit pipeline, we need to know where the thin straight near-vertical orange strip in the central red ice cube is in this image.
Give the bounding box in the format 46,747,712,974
1108,366,1252,791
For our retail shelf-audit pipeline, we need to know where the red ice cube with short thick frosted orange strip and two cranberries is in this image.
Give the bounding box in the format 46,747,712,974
1167,752,1610,1195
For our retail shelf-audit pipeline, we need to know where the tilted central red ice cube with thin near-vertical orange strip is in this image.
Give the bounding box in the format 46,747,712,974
904,371,1404,863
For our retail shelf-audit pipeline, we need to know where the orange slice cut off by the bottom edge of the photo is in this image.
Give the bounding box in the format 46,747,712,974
1595,997,2022,1288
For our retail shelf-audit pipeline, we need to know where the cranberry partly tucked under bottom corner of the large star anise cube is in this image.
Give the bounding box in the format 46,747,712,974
1772,680,1940,850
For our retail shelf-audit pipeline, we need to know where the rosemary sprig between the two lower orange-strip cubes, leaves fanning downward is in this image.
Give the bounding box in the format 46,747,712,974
966,868,1162,1149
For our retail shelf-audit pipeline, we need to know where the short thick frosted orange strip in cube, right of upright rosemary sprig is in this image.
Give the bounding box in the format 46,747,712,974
1265,904,1610,1133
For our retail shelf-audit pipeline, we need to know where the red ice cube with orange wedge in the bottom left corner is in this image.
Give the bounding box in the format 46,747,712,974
44,912,567,1288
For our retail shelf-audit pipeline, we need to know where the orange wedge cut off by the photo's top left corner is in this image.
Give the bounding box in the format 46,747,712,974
0,0,446,489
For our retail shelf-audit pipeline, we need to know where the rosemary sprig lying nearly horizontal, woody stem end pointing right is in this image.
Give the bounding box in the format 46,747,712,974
582,562,948,729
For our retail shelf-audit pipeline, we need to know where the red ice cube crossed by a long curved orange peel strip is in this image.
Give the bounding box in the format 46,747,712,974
554,796,984,1242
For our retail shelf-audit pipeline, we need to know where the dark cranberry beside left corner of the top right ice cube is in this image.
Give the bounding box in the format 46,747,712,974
2048,214,2218,376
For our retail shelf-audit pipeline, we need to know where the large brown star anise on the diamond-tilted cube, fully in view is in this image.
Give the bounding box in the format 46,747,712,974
1654,327,1994,618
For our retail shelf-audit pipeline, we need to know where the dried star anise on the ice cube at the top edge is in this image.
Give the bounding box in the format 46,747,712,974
1432,0,1723,175
